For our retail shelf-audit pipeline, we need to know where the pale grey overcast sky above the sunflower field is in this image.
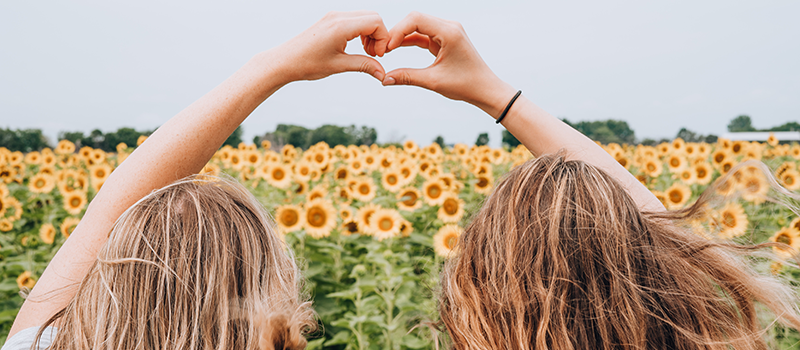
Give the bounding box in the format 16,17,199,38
0,0,800,145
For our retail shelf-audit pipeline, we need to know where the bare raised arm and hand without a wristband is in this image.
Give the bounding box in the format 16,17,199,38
9,12,388,337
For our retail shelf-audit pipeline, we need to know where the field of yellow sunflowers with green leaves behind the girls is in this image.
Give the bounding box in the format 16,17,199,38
0,137,800,350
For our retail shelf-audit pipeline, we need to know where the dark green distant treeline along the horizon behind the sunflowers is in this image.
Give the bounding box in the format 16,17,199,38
0,115,800,152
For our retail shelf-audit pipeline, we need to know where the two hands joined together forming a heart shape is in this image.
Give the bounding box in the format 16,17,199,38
276,11,516,117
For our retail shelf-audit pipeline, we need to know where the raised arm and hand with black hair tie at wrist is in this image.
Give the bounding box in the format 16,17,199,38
383,13,664,211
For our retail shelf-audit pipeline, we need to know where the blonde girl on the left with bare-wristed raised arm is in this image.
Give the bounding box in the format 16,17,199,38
3,12,388,350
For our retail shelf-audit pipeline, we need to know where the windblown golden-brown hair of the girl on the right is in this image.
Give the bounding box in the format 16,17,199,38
439,154,800,350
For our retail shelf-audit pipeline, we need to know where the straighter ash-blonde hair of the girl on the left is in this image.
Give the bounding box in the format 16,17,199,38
40,176,316,350
